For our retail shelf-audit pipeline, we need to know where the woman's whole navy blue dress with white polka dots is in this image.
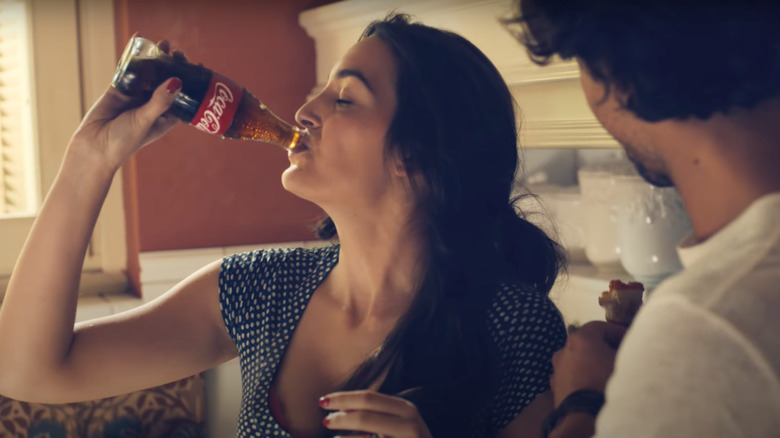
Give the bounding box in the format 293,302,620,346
219,245,566,438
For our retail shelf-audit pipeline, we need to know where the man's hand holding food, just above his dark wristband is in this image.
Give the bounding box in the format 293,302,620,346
550,321,626,407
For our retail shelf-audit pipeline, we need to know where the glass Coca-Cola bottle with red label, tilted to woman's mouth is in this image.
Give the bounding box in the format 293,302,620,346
112,36,300,150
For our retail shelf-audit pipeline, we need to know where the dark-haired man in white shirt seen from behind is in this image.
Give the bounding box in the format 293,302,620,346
509,0,780,437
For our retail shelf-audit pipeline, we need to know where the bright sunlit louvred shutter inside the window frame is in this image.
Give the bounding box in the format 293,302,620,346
0,0,37,215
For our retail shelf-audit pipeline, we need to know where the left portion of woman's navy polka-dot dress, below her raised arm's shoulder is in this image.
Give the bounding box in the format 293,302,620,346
219,246,338,438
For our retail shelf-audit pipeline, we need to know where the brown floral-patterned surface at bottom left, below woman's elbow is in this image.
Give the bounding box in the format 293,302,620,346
0,375,206,438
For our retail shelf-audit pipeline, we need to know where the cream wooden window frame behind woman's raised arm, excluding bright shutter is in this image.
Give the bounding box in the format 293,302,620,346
0,0,128,295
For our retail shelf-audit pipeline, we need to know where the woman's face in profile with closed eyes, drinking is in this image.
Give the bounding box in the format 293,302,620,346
282,37,406,214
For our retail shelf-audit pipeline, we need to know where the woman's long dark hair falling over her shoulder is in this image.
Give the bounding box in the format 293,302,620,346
319,14,564,436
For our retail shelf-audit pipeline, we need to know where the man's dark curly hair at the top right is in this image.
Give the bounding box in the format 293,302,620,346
506,0,780,121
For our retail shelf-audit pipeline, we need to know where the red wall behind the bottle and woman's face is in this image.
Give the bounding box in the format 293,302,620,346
115,0,332,260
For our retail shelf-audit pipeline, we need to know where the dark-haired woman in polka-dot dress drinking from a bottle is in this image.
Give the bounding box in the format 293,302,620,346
0,15,565,437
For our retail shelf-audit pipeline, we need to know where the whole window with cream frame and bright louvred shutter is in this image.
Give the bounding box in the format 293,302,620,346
0,0,126,294
